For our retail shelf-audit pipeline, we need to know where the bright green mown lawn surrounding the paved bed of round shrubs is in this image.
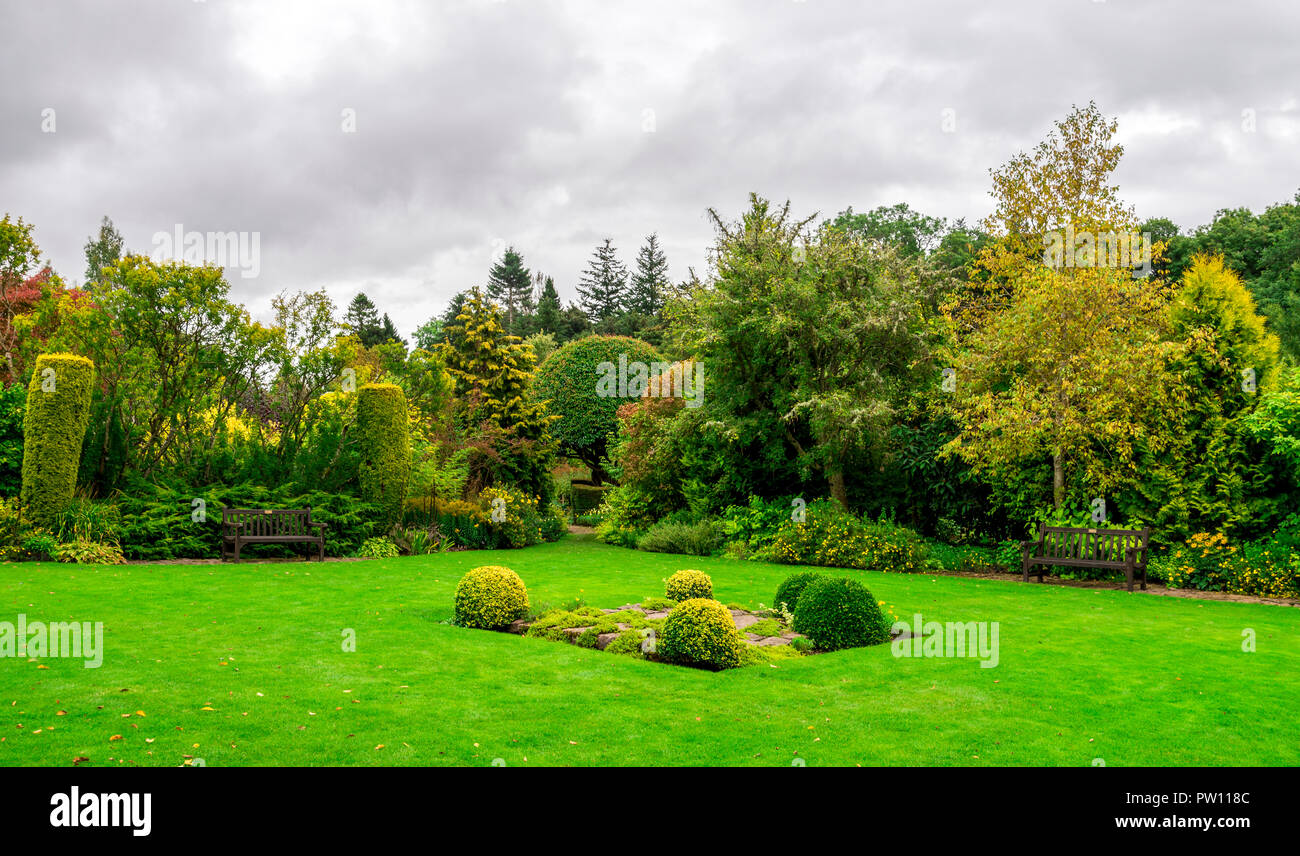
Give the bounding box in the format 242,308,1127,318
0,536,1300,766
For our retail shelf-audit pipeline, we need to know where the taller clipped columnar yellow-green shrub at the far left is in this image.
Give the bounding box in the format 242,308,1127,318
21,354,95,524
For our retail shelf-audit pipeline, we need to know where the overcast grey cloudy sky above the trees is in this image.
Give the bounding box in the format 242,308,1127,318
0,0,1300,334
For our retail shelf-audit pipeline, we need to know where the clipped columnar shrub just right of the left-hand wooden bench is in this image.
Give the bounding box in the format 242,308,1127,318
356,384,411,524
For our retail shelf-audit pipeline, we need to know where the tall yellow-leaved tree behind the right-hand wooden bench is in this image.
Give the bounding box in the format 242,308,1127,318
944,104,1177,513
